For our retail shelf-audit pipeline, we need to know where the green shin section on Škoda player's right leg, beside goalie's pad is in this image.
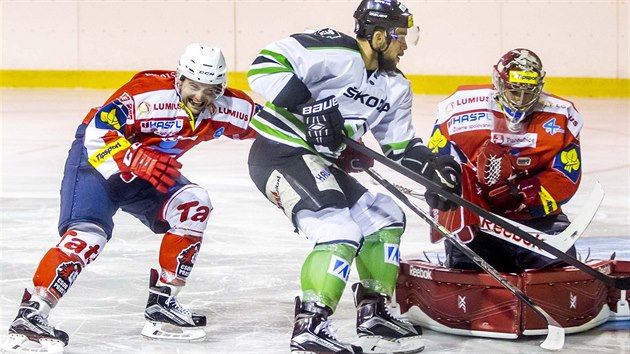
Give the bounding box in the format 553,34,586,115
357,228,403,296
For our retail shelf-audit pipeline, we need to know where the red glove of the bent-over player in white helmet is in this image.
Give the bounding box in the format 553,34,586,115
120,143,182,193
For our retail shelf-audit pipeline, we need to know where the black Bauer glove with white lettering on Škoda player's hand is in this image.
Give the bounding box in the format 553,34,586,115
297,96,343,154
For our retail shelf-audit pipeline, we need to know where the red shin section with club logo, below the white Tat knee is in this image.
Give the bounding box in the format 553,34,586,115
160,232,202,286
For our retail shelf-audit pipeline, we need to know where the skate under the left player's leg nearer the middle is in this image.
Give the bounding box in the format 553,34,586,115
142,269,206,341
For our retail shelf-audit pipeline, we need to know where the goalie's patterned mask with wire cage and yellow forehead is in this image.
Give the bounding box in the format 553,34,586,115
492,48,545,132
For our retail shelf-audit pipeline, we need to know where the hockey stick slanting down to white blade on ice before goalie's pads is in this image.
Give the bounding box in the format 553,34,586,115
363,168,564,350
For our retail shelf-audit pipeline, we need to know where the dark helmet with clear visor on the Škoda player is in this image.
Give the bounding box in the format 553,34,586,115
354,0,418,44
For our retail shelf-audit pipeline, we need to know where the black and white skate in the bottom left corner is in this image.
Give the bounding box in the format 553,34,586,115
2,290,68,354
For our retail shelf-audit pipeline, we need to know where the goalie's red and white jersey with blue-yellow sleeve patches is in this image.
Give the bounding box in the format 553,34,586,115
428,85,584,219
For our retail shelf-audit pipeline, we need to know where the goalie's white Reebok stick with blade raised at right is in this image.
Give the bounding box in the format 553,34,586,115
394,182,605,258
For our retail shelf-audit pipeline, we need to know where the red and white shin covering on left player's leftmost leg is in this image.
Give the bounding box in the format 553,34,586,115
33,228,107,306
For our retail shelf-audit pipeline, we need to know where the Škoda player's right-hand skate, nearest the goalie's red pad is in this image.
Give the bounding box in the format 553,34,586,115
352,283,424,354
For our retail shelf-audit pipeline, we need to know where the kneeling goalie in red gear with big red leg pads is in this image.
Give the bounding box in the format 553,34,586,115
397,48,596,338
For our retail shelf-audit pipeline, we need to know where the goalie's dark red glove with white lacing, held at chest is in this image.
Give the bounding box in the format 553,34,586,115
477,141,540,212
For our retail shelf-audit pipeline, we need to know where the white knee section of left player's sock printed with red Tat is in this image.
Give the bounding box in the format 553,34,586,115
162,184,212,237
